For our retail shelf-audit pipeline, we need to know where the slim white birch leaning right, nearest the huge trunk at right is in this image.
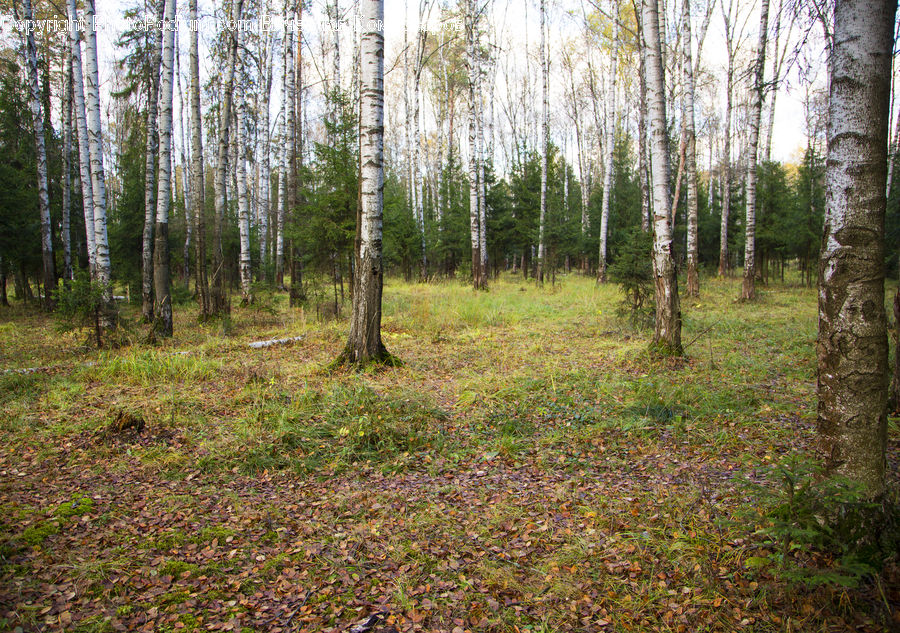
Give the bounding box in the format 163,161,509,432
741,0,769,300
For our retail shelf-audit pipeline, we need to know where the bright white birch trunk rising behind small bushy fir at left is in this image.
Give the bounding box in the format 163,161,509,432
84,0,115,308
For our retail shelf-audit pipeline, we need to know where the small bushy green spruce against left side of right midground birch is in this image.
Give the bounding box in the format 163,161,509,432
609,228,654,328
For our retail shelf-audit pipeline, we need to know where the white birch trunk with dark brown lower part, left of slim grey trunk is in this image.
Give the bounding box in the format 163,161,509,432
153,0,176,336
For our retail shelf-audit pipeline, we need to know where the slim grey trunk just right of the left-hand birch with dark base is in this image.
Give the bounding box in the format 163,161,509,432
189,0,212,320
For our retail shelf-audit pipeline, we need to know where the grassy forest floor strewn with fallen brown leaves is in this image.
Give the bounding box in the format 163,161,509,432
0,275,900,633
